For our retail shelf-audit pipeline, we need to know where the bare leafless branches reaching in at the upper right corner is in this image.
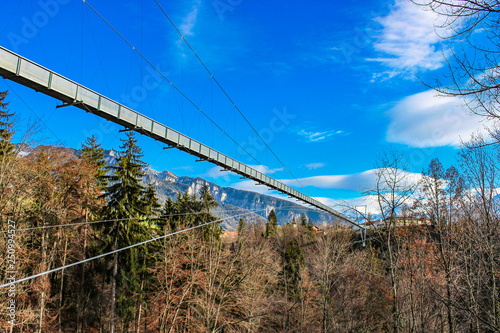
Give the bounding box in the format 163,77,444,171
412,0,500,142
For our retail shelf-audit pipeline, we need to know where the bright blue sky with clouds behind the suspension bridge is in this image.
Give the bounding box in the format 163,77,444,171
0,0,492,210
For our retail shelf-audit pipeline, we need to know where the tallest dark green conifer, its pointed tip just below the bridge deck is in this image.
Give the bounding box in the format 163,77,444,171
103,132,150,331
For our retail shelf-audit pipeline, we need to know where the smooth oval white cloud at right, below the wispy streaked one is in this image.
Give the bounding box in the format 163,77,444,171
386,91,485,148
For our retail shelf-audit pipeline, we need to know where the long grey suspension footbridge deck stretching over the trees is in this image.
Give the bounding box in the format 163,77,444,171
0,46,364,228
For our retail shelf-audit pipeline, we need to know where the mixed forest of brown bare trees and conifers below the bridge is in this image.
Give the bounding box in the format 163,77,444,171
0,83,500,332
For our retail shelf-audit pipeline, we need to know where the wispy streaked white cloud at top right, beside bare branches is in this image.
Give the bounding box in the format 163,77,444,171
367,0,444,74
